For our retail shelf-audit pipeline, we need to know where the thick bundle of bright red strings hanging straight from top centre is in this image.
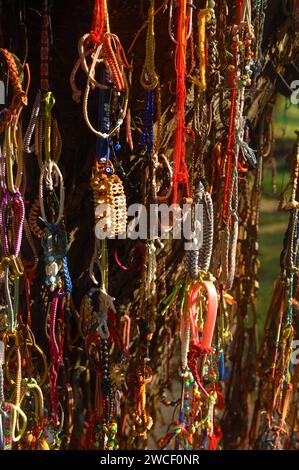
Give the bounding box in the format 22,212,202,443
173,0,189,204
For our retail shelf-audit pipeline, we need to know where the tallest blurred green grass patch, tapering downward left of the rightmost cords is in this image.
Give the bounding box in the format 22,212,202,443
257,96,299,340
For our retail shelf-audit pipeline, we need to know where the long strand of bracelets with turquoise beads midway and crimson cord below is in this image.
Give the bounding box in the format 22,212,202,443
24,0,72,448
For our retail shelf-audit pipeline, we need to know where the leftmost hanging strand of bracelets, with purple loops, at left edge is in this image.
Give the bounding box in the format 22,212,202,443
0,43,34,450
